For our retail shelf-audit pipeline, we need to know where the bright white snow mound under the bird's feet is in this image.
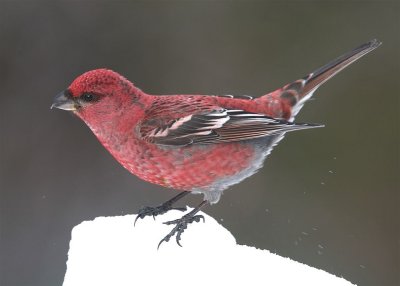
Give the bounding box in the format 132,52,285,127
63,208,353,286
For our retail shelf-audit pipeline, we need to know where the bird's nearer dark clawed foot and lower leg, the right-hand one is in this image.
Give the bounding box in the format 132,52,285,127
157,200,208,249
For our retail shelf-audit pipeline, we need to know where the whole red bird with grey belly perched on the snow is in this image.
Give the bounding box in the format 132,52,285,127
52,40,381,246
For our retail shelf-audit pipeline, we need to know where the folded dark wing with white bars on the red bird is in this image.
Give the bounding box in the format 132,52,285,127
140,108,322,146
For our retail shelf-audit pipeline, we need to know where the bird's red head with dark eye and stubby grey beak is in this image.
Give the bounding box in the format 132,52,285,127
51,69,144,125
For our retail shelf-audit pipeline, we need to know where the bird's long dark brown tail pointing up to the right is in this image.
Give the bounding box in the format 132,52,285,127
272,39,381,120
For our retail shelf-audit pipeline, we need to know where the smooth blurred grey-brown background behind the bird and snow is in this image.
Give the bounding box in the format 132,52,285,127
0,1,400,285
